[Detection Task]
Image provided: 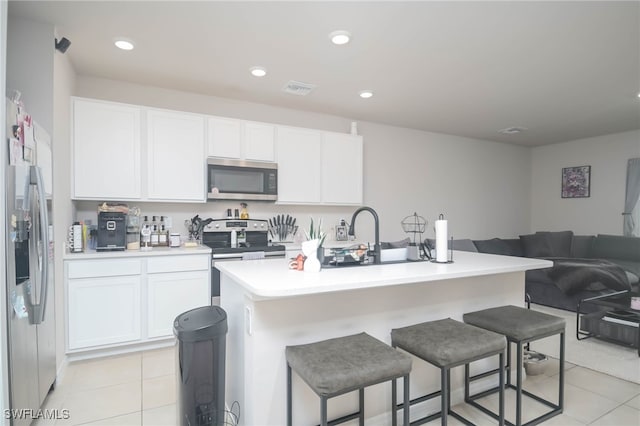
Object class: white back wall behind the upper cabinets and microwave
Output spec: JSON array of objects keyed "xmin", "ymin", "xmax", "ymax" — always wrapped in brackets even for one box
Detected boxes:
[{"xmin": 69, "ymin": 76, "xmax": 531, "ymax": 241}]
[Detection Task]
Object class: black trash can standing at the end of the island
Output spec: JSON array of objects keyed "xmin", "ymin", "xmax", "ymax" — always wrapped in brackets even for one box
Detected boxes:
[{"xmin": 173, "ymin": 306, "xmax": 227, "ymax": 426}]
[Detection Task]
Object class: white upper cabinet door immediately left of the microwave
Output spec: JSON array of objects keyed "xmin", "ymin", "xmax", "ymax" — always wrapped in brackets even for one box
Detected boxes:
[{"xmin": 147, "ymin": 110, "xmax": 206, "ymax": 202}]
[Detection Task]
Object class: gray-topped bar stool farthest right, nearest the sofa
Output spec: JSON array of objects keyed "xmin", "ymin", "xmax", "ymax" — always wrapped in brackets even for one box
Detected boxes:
[{"xmin": 463, "ymin": 305, "xmax": 565, "ymax": 426}]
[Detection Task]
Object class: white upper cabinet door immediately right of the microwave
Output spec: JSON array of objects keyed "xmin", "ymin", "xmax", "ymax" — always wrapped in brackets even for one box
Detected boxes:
[{"xmin": 276, "ymin": 127, "xmax": 322, "ymax": 204}]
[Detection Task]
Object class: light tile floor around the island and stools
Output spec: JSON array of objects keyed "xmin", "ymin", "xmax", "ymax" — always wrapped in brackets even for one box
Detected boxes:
[{"xmin": 36, "ymin": 347, "xmax": 640, "ymax": 426}]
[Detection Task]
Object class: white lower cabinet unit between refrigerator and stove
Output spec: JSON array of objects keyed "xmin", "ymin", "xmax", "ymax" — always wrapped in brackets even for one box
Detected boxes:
[{"xmin": 65, "ymin": 254, "xmax": 211, "ymax": 353}]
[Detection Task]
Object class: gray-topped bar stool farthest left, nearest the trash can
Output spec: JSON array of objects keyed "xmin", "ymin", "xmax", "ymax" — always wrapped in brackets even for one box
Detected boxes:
[{"xmin": 286, "ymin": 333, "xmax": 411, "ymax": 426}]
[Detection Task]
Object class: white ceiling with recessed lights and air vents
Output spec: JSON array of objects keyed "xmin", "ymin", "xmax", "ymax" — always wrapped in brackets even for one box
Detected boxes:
[{"xmin": 9, "ymin": 0, "xmax": 640, "ymax": 146}]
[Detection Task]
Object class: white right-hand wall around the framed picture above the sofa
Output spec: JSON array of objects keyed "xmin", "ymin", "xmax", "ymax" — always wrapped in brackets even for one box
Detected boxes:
[{"xmin": 531, "ymin": 131, "xmax": 640, "ymax": 235}]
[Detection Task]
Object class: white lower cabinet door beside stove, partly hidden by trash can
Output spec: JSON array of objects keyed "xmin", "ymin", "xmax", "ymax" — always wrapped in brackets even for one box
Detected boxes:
[{"xmin": 147, "ymin": 271, "xmax": 211, "ymax": 338}]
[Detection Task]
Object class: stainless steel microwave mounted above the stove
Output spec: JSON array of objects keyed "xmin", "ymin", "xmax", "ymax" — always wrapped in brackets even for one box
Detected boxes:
[{"xmin": 207, "ymin": 158, "xmax": 278, "ymax": 201}]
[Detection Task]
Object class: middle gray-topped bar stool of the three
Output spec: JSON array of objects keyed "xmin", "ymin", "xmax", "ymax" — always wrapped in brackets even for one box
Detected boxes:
[{"xmin": 391, "ymin": 318, "xmax": 507, "ymax": 426}]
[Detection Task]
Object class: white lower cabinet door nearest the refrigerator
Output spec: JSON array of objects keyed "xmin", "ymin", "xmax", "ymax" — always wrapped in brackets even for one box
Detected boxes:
[{"xmin": 67, "ymin": 275, "xmax": 141, "ymax": 350}]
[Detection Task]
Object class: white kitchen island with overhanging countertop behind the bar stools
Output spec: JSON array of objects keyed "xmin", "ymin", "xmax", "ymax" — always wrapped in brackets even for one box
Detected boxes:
[{"xmin": 216, "ymin": 252, "xmax": 552, "ymax": 426}]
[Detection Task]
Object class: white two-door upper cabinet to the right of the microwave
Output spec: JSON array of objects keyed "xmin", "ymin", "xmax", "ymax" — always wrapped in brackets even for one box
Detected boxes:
[{"xmin": 277, "ymin": 127, "xmax": 363, "ymax": 205}]
